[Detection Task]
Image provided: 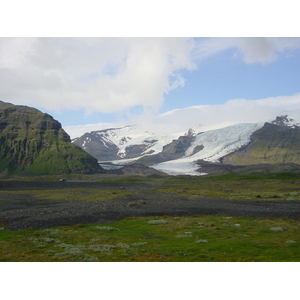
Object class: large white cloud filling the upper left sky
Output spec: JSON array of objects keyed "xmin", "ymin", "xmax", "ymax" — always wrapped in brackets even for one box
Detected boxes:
[{"xmin": 0, "ymin": 38, "xmax": 195, "ymax": 113}]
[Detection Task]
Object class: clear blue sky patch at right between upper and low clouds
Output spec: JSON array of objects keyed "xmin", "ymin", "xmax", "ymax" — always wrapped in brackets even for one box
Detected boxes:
[{"xmin": 162, "ymin": 50, "xmax": 300, "ymax": 110}]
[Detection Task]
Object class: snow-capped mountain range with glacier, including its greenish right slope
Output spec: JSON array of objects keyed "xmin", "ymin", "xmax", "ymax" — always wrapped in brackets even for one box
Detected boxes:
[{"xmin": 73, "ymin": 115, "xmax": 300, "ymax": 175}]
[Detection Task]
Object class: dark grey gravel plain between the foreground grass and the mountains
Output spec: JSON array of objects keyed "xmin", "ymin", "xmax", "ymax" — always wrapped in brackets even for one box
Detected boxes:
[{"xmin": 0, "ymin": 181, "xmax": 300, "ymax": 230}]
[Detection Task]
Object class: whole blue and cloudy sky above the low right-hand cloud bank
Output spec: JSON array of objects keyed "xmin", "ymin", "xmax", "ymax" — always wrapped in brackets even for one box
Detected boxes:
[{"xmin": 0, "ymin": 37, "xmax": 300, "ymax": 126}]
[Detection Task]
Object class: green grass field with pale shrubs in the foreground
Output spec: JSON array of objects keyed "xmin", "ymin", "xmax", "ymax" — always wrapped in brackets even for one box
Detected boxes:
[{"xmin": 0, "ymin": 216, "xmax": 300, "ymax": 262}]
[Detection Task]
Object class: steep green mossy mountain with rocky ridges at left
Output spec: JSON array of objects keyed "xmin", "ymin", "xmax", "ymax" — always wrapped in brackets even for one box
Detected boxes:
[{"xmin": 0, "ymin": 101, "xmax": 104, "ymax": 175}]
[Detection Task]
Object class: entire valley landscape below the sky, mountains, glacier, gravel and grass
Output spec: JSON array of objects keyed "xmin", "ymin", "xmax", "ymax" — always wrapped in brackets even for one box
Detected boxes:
[{"xmin": 0, "ymin": 102, "xmax": 300, "ymax": 261}]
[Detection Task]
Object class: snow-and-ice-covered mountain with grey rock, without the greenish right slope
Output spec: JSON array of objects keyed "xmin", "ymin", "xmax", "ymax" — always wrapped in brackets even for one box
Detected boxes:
[{"xmin": 73, "ymin": 116, "xmax": 300, "ymax": 175}]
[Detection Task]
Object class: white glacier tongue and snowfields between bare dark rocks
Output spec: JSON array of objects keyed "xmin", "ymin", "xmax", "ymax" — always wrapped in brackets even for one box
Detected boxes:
[{"xmin": 100, "ymin": 122, "xmax": 264, "ymax": 176}]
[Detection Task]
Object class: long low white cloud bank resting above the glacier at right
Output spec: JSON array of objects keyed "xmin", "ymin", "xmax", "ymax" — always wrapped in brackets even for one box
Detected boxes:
[{"xmin": 162, "ymin": 93, "xmax": 300, "ymax": 127}]
